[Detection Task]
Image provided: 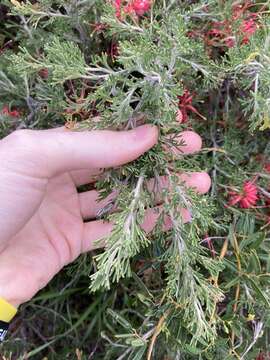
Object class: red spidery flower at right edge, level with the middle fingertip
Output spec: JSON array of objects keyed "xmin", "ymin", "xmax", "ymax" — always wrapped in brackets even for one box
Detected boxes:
[{"xmin": 228, "ymin": 181, "xmax": 259, "ymax": 209}]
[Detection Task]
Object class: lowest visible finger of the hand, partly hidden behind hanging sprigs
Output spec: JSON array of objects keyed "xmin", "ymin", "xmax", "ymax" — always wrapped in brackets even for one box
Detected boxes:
[{"xmin": 82, "ymin": 206, "xmax": 191, "ymax": 252}]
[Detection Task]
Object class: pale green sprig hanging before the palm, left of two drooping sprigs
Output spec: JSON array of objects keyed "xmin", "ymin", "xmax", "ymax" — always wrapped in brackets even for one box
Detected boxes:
[{"xmin": 91, "ymin": 175, "xmax": 150, "ymax": 291}]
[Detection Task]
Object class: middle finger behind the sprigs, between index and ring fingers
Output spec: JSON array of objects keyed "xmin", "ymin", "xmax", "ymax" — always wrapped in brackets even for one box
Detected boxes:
[{"xmin": 79, "ymin": 172, "xmax": 211, "ymax": 219}]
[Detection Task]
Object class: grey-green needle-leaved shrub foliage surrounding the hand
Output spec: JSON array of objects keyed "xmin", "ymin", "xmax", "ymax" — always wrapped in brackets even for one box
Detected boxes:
[{"xmin": 0, "ymin": 0, "xmax": 270, "ymax": 360}]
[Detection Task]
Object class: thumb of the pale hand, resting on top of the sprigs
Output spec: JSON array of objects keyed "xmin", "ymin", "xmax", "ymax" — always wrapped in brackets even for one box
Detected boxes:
[{"xmin": 45, "ymin": 125, "xmax": 158, "ymax": 173}]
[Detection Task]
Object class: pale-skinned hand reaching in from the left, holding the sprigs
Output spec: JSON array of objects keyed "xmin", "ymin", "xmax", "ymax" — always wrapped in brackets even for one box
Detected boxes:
[{"xmin": 0, "ymin": 125, "xmax": 211, "ymax": 307}]
